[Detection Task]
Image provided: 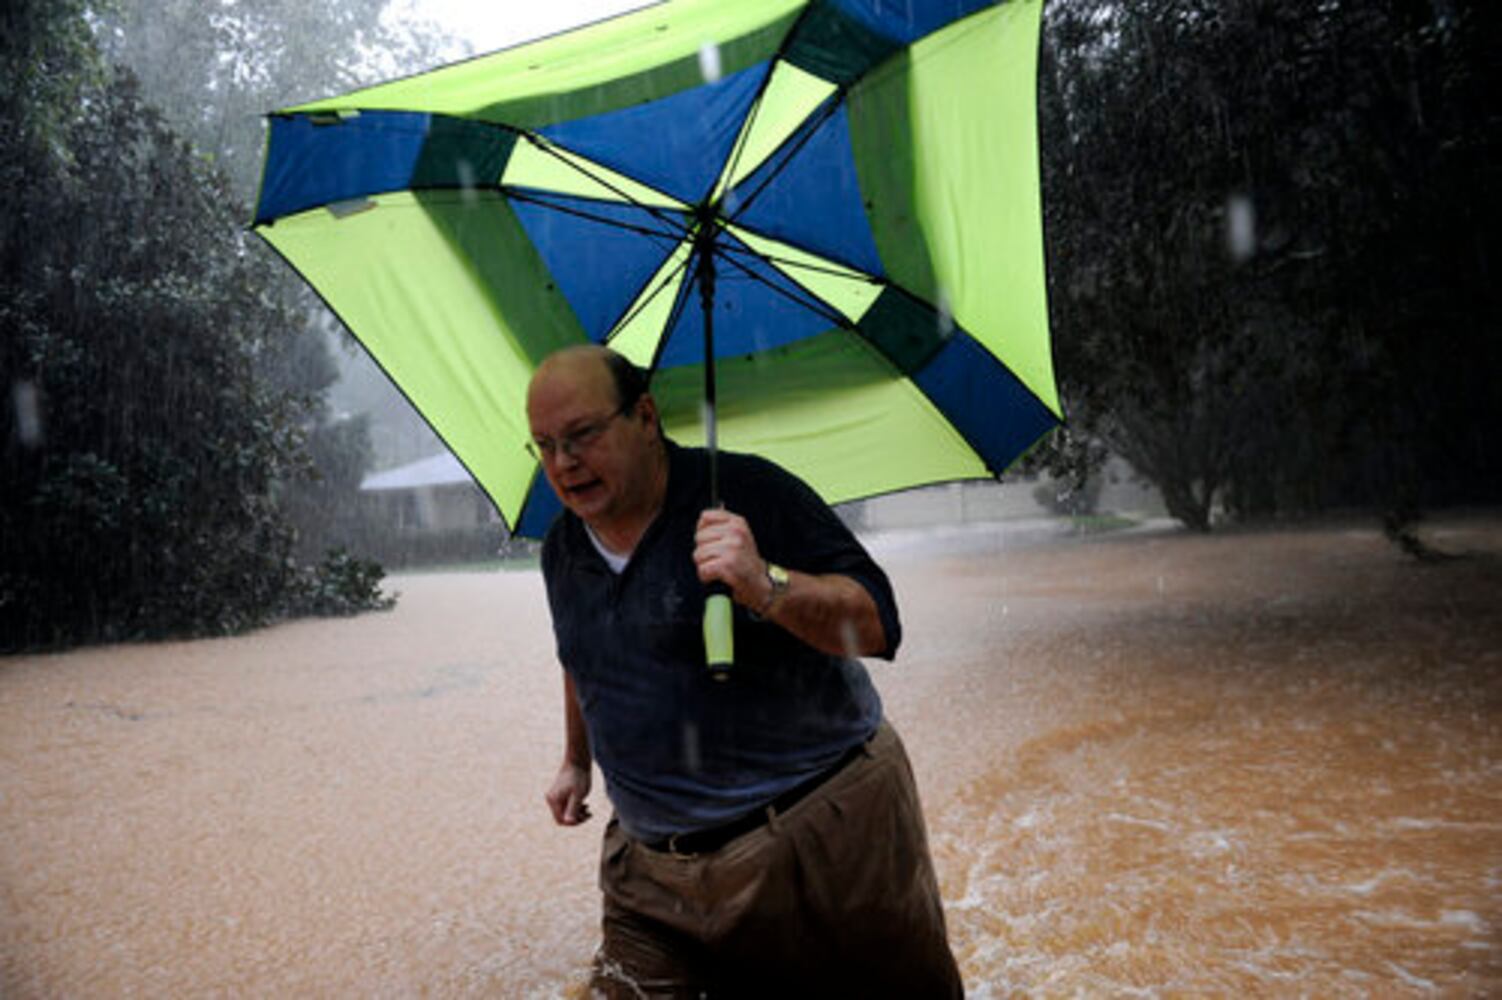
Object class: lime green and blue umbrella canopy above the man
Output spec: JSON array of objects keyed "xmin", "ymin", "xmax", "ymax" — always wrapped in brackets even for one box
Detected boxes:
[{"xmin": 254, "ymin": 0, "xmax": 1060, "ymax": 536}]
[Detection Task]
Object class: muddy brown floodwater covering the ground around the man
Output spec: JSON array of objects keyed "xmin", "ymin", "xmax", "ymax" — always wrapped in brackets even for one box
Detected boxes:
[{"xmin": 0, "ymin": 515, "xmax": 1502, "ymax": 997}]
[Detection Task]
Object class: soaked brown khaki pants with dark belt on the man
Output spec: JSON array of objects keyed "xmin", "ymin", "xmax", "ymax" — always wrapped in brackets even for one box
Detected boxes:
[{"xmin": 592, "ymin": 722, "xmax": 963, "ymax": 998}]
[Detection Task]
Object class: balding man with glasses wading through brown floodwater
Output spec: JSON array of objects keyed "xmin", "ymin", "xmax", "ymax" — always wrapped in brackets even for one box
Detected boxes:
[{"xmin": 527, "ymin": 347, "xmax": 961, "ymax": 997}]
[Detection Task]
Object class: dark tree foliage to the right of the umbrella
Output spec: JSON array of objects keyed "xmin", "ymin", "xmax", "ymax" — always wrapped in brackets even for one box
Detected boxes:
[{"xmin": 1039, "ymin": 0, "xmax": 1502, "ymax": 529}]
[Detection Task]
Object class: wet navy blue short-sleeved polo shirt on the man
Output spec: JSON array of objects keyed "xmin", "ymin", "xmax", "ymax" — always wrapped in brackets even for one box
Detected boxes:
[{"xmin": 542, "ymin": 441, "xmax": 901, "ymax": 841}]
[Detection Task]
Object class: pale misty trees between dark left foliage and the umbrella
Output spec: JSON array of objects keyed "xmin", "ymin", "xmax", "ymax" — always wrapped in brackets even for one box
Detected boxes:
[{"xmin": 98, "ymin": 0, "xmax": 456, "ymax": 559}]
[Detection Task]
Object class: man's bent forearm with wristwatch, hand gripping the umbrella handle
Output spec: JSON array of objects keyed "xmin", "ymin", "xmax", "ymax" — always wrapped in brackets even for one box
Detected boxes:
[{"xmin": 694, "ymin": 511, "xmax": 888, "ymax": 656}]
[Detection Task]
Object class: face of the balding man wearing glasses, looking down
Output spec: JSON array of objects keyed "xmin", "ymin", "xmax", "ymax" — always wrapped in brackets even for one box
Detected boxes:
[{"xmin": 527, "ymin": 354, "xmax": 656, "ymax": 530}]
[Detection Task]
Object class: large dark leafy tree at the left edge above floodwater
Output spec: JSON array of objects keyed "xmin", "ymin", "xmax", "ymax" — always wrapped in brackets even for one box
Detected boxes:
[{"xmin": 0, "ymin": 0, "xmax": 396, "ymax": 649}]
